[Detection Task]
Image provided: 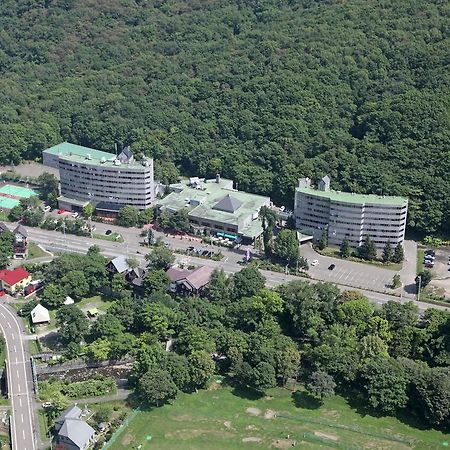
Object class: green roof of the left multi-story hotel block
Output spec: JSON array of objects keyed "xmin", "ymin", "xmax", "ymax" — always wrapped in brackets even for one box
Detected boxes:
[{"xmin": 44, "ymin": 142, "xmax": 149, "ymax": 171}]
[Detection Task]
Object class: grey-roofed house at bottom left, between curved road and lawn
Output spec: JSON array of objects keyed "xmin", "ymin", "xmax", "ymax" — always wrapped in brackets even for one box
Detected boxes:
[{"xmin": 54, "ymin": 405, "xmax": 95, "ymax": 450}]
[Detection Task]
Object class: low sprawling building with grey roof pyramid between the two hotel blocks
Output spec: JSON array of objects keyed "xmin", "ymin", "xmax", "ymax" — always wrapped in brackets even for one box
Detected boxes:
[{"xmin": 156, "ymin": 176, "xmax": 270, "ymax": 239}]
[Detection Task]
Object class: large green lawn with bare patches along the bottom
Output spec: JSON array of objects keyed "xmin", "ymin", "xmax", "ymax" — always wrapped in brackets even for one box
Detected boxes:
[{"xmin": 107, "ymin": 387, "xmax": 450, "ymax": 450}]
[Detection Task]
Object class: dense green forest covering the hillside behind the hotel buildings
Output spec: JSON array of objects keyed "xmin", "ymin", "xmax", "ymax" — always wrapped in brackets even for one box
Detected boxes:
[{"xmin": 0, "ymin": 0, "xmax": 450, "ymax": 233}]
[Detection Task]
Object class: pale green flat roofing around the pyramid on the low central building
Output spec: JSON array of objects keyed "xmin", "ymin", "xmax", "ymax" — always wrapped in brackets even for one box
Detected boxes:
[{"xmin": 157, "ymin": 179, "xmax": 270, "ymax": 237}]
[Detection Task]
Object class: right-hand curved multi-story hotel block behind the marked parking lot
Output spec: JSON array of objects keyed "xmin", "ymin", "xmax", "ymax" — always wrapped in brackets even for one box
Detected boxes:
[{"xmin": 294, "ymin": 176, "xmax": 408, "ymax": 248}]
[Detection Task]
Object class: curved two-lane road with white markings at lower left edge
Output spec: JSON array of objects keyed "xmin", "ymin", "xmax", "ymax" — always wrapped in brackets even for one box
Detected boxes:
[{"xmin": 0, "ymin": 303, "xmax": 36, "ymax": 450}]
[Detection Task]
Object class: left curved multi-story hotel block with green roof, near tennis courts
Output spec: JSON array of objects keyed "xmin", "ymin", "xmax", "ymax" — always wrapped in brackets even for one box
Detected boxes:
[{"xmin": 43, "ymin": 142, "xmax": 155, "ymax": 217}]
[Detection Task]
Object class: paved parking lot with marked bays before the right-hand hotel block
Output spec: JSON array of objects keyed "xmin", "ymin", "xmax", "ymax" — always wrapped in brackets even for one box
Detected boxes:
[{"xmin": 302, "ymin": 245, "xmax": 415, "ymax": 296}]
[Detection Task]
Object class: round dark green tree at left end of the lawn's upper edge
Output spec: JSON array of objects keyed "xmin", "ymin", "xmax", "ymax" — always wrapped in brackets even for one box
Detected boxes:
[{"xmin": 136, "ymin": 367, "xmax": 178, "ymax": 406}]
